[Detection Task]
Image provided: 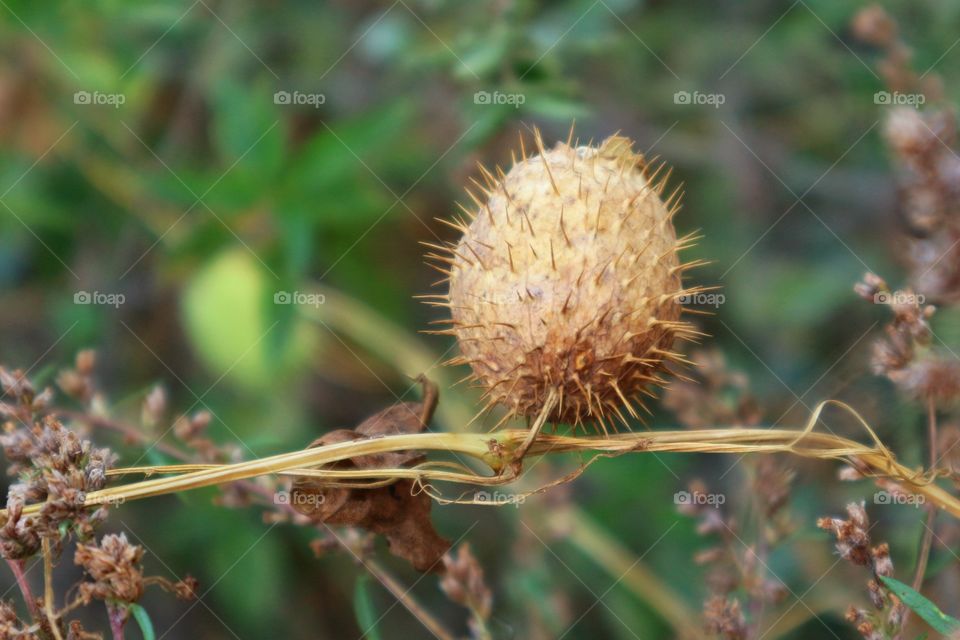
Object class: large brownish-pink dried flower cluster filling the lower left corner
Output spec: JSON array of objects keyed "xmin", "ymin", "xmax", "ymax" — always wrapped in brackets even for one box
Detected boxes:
[{"xmin": 0, "ymin": 360, "xmax": 196, "ymax": 640}]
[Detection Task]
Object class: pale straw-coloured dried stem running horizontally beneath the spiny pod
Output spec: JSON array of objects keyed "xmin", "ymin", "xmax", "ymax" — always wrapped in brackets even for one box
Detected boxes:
[{"xmin": 24, "ymin": 401, "xmax": 960, "ymax": 518}]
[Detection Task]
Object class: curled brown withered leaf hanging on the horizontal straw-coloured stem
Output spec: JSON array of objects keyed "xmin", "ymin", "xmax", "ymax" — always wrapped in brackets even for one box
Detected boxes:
[{"xmin": 290, "ymin": 376, "xmax": 450, "ymax": 571}]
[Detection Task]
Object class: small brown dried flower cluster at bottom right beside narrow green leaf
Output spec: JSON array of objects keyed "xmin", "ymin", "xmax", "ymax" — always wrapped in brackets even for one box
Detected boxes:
[{"xmin": 817, "ymin": 502, "xmax": 907, "ymax": 640}]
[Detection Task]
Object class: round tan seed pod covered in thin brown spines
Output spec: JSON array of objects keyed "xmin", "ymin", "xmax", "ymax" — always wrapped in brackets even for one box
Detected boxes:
[{"xmin": 426, "ymin": 131, "xmax": 702, "ymax": 429}]
